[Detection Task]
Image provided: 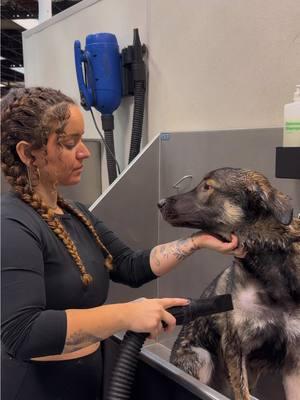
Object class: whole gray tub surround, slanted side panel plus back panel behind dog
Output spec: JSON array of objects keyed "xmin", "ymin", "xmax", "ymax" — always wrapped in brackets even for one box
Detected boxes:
[{"xmin": 90, "ymin": 128, "xmax": 300, "ymax": 400}]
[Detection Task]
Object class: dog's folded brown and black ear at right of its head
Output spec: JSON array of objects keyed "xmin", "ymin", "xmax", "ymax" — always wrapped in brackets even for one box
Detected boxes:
[{"xmin": 248, "ymin": 180, "xmax": 293, "ymax": 225}]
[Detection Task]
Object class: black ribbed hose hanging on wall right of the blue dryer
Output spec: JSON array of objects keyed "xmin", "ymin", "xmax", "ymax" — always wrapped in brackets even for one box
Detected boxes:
[{"xmin": 129, "ymin": 82, "xmax": 145, "ymax": 163}]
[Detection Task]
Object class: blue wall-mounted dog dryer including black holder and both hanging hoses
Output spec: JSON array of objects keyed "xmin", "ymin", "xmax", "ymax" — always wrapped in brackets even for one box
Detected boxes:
[{"xmin": 74, "ymin": 29, "xmax": 146, "ymax": 183}]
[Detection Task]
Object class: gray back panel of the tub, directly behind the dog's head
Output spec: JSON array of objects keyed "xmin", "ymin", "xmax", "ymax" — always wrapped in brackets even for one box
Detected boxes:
[{"xmin": 159, "ymin": 128, "xmax": 300, "ymax": 297}]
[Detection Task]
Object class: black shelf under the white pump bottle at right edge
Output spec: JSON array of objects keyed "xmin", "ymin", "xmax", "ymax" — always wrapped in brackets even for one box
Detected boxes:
[{"xmin": 275, "ymin": 147, "xmax": 300, "ymax": 179}]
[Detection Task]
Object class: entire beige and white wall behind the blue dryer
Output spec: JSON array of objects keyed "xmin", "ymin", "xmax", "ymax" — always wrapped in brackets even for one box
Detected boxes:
[{"xmin": 24, "ymin": 0, "xmax": 300, "ymax": 187}]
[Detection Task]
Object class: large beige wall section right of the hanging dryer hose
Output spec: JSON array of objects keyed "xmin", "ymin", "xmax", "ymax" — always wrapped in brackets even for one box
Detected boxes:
[{"xmin": 148, "ymin": 0, "xmax": 300, "ymax": 136}]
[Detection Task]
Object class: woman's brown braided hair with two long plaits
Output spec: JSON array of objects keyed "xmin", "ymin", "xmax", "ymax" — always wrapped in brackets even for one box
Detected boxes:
[{"xmin": 1, "ymin": 87, "xmax": 113, "ymax": 286}]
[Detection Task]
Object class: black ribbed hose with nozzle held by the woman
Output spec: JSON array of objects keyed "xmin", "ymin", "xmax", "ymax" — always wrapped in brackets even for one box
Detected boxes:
[{"xmin": 107, "ymin": 294, "xmax": 233, "ymax": 400}]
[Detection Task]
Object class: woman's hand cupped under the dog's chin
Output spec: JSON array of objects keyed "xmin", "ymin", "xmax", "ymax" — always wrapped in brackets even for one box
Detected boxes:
[{"xmin": 192, "ymin": 232, "xmax": 247, "ymax": 258}]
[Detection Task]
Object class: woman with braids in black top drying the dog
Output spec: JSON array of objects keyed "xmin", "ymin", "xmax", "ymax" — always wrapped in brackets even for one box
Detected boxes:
[{"xmin": 1, "ymin": 88, "xmax": 244, "ymax": 400}]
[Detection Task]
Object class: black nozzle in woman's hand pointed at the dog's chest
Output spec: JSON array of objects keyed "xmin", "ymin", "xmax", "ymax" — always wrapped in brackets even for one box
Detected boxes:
[{"xmin": 167, "ymin": 294, "xmax": 233, "ymax": 325}]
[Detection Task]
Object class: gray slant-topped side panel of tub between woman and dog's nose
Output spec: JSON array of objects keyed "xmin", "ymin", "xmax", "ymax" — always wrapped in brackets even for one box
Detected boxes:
[{"xmin": 93, "ymin": 141, "xmax": 159, "ymax": 302}]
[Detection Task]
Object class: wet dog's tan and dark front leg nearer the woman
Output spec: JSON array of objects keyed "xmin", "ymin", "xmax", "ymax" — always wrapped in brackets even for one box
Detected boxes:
[{"xmin": 222, "ymin": 332, "xmax": 250, "ymax": 400}]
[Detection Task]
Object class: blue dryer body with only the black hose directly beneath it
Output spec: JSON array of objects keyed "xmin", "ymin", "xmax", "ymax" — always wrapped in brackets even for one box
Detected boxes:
[{"xmin": 74, "ymin": 33, "xmax": 122, "ymax": 183}]
